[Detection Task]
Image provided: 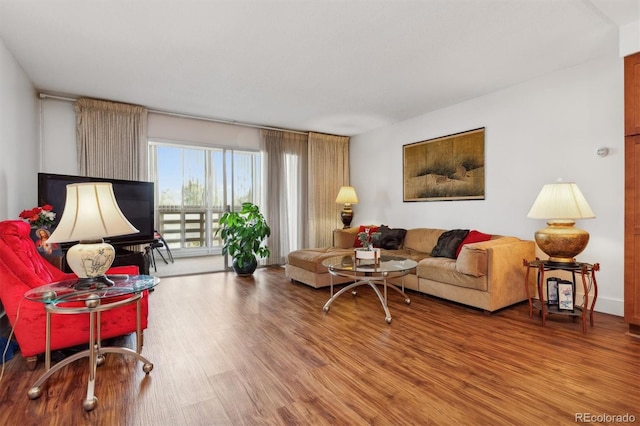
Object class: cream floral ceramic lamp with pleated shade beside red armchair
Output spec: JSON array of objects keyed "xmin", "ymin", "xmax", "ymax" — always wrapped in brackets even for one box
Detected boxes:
[{"xmin": 48, "ymin": 182, "xmax": 140, "ymax": 289}]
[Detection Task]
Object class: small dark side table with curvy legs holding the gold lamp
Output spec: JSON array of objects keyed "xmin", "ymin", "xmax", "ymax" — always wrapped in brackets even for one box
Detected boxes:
[{"xmin": 523, "ymin": 259, "xmax": 600, "ymax": 333}]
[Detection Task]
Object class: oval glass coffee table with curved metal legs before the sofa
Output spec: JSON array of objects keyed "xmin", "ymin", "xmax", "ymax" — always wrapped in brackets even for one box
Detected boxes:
[{"xmin": 322, "ymin": 255, "xmax": 418, "ymax": 324}]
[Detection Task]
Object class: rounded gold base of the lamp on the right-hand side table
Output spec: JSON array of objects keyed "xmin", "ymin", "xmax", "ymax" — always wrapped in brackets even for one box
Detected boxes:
[{"xmin": 535, "ymin": 220, "xmax": 589, "ymax": 265}]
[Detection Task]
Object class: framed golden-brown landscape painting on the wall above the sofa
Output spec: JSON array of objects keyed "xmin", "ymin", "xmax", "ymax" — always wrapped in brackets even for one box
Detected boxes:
[{"xmin": 403, "ymin": 128, "xmax": 484, "ymax": 201}]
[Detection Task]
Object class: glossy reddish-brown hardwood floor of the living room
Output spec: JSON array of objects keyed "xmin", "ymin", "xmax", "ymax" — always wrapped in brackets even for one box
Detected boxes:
[{"xmin": 0, "ymin": 267, "xmax": 640, "ymax": 425}]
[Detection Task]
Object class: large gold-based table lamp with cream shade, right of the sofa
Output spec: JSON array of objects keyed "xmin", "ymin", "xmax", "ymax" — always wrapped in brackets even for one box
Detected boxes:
[{"xmin": 527, "ymin": 179, "xmax": 596, "ymax": 264}]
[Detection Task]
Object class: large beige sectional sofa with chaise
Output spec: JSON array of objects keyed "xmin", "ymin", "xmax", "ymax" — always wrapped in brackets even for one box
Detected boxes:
[{"xmin": 285, "ymin": 227, "xmax": 535, "ymax": 312}]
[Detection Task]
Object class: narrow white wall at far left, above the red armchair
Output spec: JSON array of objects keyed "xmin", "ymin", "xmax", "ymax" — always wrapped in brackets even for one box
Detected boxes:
[{"xmin": 0, "ymin": 39, "xmax": 40, "ymax": 220}]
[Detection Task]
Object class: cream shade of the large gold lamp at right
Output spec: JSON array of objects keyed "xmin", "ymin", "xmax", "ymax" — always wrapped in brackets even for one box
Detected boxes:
[{"xmin": 527, "ymin": 182, "xmax": 596, "ymax": 220}]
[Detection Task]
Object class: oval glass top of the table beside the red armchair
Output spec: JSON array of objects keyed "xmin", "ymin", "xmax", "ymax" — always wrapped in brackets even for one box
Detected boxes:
[{"xmin": 24, "ymin": 275, "xmax": 160, "ymax": 303}]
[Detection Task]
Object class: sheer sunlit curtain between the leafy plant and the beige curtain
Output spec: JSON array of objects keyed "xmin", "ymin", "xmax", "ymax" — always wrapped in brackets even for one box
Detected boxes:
[{"xmin": 260, "ymin": 130, "xmax": 309, "ymax": 264}]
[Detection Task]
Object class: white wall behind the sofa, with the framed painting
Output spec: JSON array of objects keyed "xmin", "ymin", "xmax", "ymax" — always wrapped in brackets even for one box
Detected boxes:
[{"xmin": 350, "ymin": 50, "xmax": 624, "ymax": 316}]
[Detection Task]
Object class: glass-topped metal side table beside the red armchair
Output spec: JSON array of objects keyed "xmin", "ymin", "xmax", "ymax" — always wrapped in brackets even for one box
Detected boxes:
[{"xmin": 24, "ymin": 275, "xmax": 160, "ymax": 411}]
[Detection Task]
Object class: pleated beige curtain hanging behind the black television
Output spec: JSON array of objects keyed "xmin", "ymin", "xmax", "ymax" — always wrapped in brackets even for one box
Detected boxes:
[{"xmin": 75, "ymin": 98, "xmax": 148, "ymax": 180}]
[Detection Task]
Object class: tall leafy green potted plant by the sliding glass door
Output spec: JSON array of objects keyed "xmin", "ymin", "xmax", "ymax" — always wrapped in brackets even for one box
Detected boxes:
[{"xmin": 215, "ymin": 203, "xmax": 271, "ymax": 276}]
